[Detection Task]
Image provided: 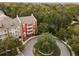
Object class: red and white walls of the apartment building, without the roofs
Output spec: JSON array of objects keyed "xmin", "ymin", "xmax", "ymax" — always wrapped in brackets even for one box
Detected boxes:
[{"xmin": 0, "ymin": 21, "xmax": 37, "ymax": 39}]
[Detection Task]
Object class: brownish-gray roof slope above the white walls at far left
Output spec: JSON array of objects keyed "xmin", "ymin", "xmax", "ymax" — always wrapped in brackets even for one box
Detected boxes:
[{"xmin": 0, "ymin": 16, "xmax": 19, "ymax": 31}]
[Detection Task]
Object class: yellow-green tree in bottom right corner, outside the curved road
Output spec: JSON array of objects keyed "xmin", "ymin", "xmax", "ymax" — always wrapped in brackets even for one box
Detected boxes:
[{"xmin": 68, "ymin": 35, "xmax": 79, "ymax": 56}]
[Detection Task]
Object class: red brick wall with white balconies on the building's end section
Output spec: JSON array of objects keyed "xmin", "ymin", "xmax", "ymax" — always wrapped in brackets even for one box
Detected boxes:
[{"xmin": 21, "ymin": 21, "xmax": 36, "ymax": 37}]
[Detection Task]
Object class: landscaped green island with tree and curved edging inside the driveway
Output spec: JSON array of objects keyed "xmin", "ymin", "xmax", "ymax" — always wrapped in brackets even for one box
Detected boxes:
[{"xmin": 33, "ymin": 33, "xmax": 60, "ymax": 56}]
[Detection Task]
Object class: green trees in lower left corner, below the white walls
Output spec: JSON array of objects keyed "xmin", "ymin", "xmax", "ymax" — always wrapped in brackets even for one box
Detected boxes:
[{"xmin": 0, "ymin": 36, "xmax": 23, "ymax": 56}]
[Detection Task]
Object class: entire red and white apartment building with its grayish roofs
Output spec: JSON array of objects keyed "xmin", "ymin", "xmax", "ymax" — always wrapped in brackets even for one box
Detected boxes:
[{"xmin": 0, "ymin": 12, "xmax": 37, "ymax": 39}]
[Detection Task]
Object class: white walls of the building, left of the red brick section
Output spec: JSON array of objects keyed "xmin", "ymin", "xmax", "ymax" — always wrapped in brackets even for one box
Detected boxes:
[{"xmin": 0, "ymin": 27, "xmax": 21, "ymax": 39}]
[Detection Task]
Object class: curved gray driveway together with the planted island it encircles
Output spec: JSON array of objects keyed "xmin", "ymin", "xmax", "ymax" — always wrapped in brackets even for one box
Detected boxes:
[{"xmin": 22, "ymin": 33, "xmax": 73, "ymax": 56}]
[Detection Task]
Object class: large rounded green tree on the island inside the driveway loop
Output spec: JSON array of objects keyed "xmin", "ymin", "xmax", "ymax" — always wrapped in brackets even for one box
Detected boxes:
[{"xmin": 37, "ymin": 33, "xmax": 56, "ymax": 53}]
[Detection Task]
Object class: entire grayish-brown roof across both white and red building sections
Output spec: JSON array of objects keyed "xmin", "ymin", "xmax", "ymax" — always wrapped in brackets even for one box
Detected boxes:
[{"xmin": 0, "ymin": 14, "xmax": 36, "ymax": 32}]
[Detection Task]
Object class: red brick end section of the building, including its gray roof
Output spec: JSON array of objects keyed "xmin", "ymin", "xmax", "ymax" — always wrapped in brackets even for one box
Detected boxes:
[{"xmin": 16, "ymin": 14, "xmax": 37, "ymax": 38}]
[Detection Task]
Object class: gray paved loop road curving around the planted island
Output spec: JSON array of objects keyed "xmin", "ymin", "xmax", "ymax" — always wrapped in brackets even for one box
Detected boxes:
[{"xmin": 20, "ymin": 39, "xmax": 70, "ymax": 56}]
